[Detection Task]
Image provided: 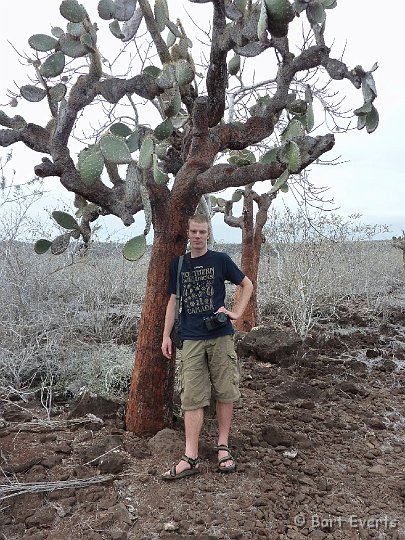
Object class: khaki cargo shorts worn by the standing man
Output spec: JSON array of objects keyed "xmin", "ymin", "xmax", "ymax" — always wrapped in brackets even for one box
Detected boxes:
[{"xmin": 180, "ymin": 335, "xmax": 240, "ymax": 411}]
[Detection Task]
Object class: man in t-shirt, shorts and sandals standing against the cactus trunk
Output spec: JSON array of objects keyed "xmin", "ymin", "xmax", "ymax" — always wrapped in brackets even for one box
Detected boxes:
[{"xmin": 162, "ymin": 215, "xmax": 253, "ymax": 480}]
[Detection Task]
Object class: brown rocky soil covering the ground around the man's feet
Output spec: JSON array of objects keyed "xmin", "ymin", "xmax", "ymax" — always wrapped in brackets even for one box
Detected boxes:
[{"xmin": 0, "ymin": 307, "xmax": 405, "ymax": 540}]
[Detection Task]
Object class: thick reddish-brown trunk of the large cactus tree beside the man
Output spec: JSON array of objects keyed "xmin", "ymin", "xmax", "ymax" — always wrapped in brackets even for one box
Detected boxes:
[{"xmin": 126, "ymin": 175, "xmax": 204, "ymax": 436}]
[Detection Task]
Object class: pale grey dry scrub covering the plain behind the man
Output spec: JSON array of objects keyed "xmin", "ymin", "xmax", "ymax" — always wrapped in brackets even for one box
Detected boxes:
[{"xmin": 0, "ymin": 226, "xmax": 404, "ymax": 413}]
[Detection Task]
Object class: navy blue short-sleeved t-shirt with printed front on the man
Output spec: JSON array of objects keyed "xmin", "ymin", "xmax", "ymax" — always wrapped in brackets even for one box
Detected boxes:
[{"xmin": 169, "ymin": 250, "xmax": 245, "ymax": 340}]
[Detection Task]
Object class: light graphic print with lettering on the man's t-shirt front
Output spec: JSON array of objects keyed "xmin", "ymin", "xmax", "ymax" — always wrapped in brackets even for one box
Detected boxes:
[{"xmin": 181, "ymin": 266, "xmax": 215, "ymax": 315}]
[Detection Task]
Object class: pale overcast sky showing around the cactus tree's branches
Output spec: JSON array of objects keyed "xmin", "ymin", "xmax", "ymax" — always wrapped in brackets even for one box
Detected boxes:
[{"xmin": 0, "ymin": 0, "xmax": 405, "ymax": 242}]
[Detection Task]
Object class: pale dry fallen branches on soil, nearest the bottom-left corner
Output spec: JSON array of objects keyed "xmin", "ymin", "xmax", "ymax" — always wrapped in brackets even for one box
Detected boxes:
[{"xmin": 0, "ymin": 474, "xmax": 115, "ymax": 501}]
